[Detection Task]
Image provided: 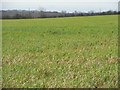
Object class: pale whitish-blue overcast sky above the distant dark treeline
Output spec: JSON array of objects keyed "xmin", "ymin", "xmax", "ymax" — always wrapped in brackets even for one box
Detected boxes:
[{"xmin": 0, "ymin": 0, "xmax": 119, "ymax": 12}]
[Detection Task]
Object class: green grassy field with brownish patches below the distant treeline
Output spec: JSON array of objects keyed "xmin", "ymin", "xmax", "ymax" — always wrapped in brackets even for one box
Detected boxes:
[{"xmin": 2, "ymin": 15, "xmax": 118, "ymax": 88}]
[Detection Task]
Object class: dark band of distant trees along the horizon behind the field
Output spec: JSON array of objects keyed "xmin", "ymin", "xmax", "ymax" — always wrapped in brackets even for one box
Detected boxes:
[{"xmin": 0, "ymin": 10, "xmax": 120, "ymax": 19}]
